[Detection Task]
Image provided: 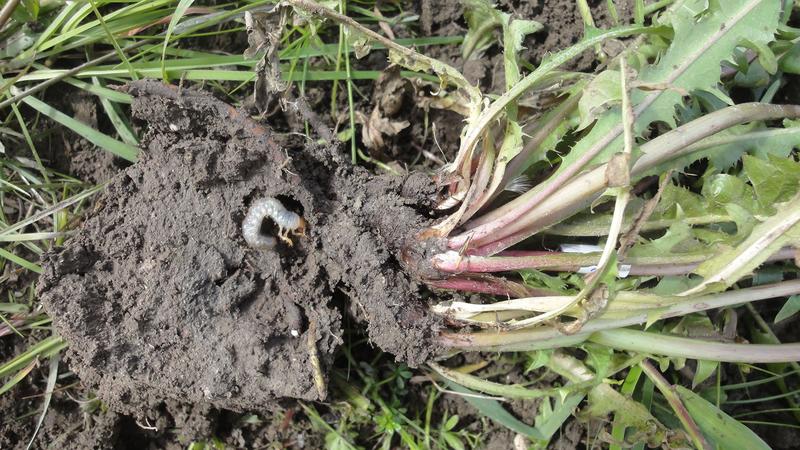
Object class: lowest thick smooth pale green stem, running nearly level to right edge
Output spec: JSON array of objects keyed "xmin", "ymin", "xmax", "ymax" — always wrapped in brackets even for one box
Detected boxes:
[{"xmin": 589, "ymin": 329, "xmax": 800, "ymax": 364}]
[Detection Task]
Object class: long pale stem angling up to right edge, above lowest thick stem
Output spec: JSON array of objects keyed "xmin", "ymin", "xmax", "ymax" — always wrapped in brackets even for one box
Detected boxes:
[{"xmin": 439, "ymin": 280, "xmax": 800, "ymax": 351}]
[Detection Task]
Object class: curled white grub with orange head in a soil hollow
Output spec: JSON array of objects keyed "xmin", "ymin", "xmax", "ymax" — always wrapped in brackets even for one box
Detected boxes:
[{"xmin": 242, "ymin": 197, "xmax": 306, "ymax": 250}]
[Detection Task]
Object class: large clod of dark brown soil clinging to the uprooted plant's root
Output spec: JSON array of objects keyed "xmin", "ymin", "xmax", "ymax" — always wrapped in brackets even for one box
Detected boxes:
[{"xmin": 39, "ymin": 81, "xmax": 439, "ymax": 412}]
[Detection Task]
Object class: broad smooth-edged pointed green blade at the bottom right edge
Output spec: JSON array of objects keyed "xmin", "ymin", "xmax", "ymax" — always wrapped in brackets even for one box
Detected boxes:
[{"xmin": 675, "ymin": 385, "xmax": 770, "ymax": 450}]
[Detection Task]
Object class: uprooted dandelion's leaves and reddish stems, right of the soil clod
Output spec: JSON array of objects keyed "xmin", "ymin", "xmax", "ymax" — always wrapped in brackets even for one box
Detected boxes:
[{"xmin": 286, "ymin": 0, "xmax": 800, "ymax": 448}]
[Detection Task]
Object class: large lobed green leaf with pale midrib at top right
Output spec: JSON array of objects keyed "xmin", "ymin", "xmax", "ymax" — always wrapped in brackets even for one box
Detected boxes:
[{"xmin": 559, "ymin": 0, "xmax": 780, "ymax": 179}]
